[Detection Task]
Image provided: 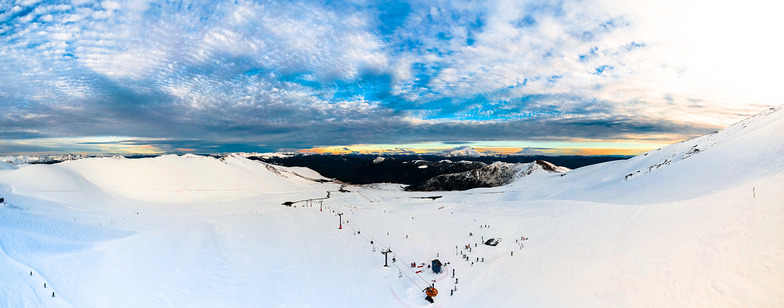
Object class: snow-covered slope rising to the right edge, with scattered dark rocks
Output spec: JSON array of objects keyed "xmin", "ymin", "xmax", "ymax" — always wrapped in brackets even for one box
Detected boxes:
[{"xmin": 513, "ymin": 108, "xmax": 784, "ymax": 204}]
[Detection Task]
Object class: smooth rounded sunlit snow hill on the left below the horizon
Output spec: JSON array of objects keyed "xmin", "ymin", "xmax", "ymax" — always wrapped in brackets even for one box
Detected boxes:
[{"xmin": 3, "ymin": 154, "xmax": 324, "ymax": 202}]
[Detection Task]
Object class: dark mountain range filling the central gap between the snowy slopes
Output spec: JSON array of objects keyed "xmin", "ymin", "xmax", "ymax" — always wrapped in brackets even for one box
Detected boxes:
[{"xmin": 254, "ymin": 153, "xmax": 628, "ymax": 190}]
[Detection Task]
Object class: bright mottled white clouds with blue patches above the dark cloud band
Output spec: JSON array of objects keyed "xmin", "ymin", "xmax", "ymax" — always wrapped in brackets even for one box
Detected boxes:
[{"xmin": 0, "ymin": 0, "xmax": 784, "ymax": 150}]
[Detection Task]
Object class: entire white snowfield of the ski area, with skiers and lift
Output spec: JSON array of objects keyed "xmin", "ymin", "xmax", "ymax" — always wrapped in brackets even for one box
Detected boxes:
[{"xmin": 0, "ymin": 108, "xmax": 784, "ymax": 307}]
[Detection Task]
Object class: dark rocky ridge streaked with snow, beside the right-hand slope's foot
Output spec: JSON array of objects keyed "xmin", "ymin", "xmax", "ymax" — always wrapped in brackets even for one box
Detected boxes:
[{"xmin": 407, "ymin": 160, "xmax": 569, "ymax": 191}]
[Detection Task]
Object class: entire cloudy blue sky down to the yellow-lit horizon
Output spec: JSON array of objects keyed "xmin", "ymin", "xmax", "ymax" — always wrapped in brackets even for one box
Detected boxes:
[{"xmin": 0, "ymin": 0, "xmax": 784, "ymax": 155}]
